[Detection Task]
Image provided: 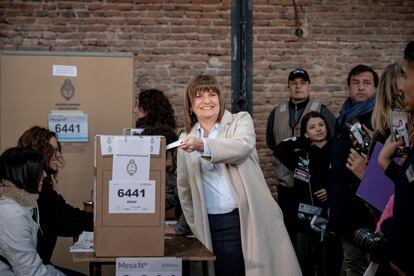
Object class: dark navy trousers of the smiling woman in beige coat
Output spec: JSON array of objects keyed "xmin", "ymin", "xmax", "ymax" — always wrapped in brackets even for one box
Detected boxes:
[{"xmin": 208, "ymin": 209, "xmax": 245, "ymax": 276}]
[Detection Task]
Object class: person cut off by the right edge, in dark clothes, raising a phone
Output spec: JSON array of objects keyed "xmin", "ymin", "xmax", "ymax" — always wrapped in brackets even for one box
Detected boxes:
[{"xmin": 378, "ymin": 41, "xmax": 414, "ymax": 275}]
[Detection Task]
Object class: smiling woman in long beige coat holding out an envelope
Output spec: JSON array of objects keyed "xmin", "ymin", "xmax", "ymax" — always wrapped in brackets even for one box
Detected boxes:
[{"xmin": 177, "ymin": 75, "xmax": 302, "ymax": 276}]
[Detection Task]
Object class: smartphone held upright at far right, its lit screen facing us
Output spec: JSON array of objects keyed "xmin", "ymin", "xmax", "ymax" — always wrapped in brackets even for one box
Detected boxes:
[{"xmin": 389, "ymin": 109, "xmax": 410, "ymax": 155}]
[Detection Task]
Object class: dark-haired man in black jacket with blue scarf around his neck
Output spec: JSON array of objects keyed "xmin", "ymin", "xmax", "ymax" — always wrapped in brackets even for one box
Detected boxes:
[{"xmin": 328, "ymin": 65, "xmax": 378, "ymax": 276}]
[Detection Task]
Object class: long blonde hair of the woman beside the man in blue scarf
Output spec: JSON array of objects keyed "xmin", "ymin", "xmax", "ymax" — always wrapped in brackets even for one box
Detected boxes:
[{"xmin": 371, "ymin": 62, "xmax": 405, "ymax": 135}]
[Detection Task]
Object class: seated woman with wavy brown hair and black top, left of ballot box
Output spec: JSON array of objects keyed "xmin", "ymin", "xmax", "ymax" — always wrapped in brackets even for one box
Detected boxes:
[{"xmin": 18, "ymin": 126, "xmax": 93, "ymax": 275}]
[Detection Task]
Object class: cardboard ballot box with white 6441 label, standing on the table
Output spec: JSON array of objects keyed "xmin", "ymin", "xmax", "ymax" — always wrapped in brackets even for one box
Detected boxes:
[{"xmin": 94, "ymin": 136, "xmax": 166, "ymax": 257}]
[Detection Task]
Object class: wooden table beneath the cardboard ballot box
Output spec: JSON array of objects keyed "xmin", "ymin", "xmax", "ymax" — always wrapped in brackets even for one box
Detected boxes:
[{"xmin": 71, "ymin": 235, "xmax": 216, "ymax": 276}]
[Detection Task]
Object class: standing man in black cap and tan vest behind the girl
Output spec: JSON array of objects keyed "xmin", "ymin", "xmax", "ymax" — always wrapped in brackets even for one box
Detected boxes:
[{"xmin": 266, "ymin": 68, "xmax": 335, "ymax": 239}]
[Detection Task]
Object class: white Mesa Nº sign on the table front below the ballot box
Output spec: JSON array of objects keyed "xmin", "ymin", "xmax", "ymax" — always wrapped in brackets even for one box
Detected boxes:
[{"xmin": 115, "ymin": 257, "xmax": 182, "ymax": 276}]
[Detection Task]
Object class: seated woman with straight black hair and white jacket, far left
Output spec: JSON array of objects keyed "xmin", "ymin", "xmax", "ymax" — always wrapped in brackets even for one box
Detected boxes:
[{"xmin": 0, "ymin": 148, "xmax": 65, "ymax": 276}]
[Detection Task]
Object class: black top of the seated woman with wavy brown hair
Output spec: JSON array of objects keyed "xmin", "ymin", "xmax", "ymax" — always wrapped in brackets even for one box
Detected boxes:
[{"xmin": 37, "ymin": 188, "xmax": 93, "ymax": 264}]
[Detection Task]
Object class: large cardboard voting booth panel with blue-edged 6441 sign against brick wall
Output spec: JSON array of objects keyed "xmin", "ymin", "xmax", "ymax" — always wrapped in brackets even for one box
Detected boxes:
[{"xmin": 0, "ymin": 51, "xmax": 133, "ymax": 274}]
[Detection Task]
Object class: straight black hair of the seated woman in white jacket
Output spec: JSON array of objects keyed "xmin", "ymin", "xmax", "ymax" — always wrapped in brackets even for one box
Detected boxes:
[{"xmin": 0, "ymin": 147, "xmax": 43, "ymax": 194}]
